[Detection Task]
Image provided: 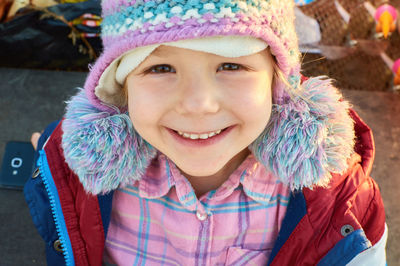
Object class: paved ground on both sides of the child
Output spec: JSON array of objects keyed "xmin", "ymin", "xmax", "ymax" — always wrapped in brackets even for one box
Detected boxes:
[{"xmin": 0, "ymin": 68, "xmax": 400, "ymax": 266}]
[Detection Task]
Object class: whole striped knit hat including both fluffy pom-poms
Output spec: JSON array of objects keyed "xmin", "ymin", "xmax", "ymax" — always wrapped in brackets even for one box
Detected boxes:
[{"xmin": 62, "ymin": 0, "xmax": 354, "ymax": 194}]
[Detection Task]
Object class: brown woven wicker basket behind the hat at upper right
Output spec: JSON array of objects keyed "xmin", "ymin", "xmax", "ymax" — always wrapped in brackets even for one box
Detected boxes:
[{"xmin": 300, "ymin": 0, "xmax": 400, "ymax": 91}]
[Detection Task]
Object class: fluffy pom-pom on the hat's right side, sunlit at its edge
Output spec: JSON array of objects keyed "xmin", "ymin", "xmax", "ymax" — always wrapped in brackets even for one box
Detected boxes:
[{"xmin": 249, "ymin": 76, "xmax": 355, "ymax": 190}]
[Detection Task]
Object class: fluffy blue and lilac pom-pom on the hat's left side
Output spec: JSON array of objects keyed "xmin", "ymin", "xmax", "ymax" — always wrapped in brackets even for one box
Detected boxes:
[{"xmin": 62, "ymin": 90, "xmax": 156, "ymax": 194}]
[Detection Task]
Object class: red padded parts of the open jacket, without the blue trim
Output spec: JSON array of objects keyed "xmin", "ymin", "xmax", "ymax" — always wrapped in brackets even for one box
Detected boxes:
[{"xmin": 39, "ymin": 110, "xmax": 385, "ymax": 266}]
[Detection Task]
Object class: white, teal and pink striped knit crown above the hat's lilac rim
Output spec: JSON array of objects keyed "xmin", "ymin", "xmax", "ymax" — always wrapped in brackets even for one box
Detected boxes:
[{"xmin": 102, "ymin": 0, "xmax": 298, "ymax": 60}]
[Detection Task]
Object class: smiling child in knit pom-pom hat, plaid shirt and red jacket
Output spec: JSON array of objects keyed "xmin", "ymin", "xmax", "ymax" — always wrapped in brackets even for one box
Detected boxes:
[{"xmin": 25, "ymin": 0, "xmax": 387, "ymax": 265}]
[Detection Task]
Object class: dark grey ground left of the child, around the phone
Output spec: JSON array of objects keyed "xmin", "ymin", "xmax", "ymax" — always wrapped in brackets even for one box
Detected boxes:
[{"xmin": 0, "ymin": 68, "xmax": 85, "ymax": 266}]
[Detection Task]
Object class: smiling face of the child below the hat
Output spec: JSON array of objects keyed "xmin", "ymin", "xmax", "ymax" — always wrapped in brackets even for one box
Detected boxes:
[{"xmin": 126, "ymin": 46, "xmax": 273, "ymax": 177}]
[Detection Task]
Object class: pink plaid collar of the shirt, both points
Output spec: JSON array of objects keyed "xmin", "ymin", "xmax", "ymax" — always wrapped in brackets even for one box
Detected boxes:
[{"xmin": 138, "ymin": 153, "xmax": 288, "ymax": 210}]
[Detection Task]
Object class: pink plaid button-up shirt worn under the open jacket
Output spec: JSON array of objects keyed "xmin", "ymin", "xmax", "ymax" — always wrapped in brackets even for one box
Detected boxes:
[{"xmin": 104, "ymin": 155, "xmax": 289, "ymax": 265}]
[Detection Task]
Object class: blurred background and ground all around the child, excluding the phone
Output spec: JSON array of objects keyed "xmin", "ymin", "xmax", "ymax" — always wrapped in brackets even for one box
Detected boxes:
[{"xmin": 0, "ymin": 0, "xmax": 400, "ymax": 265}]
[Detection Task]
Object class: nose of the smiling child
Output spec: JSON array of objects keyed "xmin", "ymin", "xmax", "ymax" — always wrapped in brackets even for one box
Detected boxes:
[{"xmin": 177, "ymin": 72, "xmax": 221, "ymax": 115}]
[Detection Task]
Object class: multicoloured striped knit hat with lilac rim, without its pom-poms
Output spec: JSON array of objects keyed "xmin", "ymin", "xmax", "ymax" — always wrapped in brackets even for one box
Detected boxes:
[{"xmin": 85, "ymin": 0, "xmax": 300, "ymax": 111}]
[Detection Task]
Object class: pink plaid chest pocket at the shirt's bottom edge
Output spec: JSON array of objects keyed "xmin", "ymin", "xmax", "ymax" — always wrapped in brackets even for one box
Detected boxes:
[{"xmin": 225, "ymin": 247, "xmax": 272, "ymax": 266}]
